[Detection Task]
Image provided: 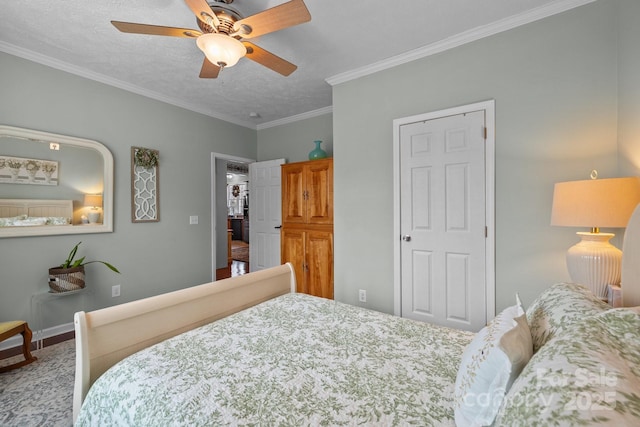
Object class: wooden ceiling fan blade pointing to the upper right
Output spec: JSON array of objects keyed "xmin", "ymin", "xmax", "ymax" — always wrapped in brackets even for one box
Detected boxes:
[{"xmin": 233, "ymin": 0, "xmax": 311, "ymax": 39}]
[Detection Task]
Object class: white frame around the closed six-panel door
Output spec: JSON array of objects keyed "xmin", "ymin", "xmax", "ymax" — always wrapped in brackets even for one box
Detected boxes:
[{"xmin": 393, "ymin": 99, "xmax": 496, "ymax": 322}]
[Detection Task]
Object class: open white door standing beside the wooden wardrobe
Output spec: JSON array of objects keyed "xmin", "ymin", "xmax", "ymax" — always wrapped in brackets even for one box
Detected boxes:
[{"xmin": 249, "ymin": 159, "xmax": 284, "ymax": 271}]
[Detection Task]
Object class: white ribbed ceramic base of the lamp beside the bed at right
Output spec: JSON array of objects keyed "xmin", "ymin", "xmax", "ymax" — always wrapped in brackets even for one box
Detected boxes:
[{"xmin": 567, "ymin": 232, "xmax": 622, "ymax": 299}]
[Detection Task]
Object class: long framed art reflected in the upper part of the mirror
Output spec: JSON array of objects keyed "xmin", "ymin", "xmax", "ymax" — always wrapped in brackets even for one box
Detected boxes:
[{"xmin": 0, "ymin": 156, "xmax": 58, "ymax": 185}]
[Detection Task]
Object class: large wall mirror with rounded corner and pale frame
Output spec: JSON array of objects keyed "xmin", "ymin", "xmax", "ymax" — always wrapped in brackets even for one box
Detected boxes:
[{"xmin": 0, "ymin": 125, "xmax": 113, "ymax": 237}]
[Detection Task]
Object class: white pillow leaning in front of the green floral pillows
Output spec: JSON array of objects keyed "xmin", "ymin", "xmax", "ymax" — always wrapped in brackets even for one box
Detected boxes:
[{"xmin": 454, "ymin": 295, "xmax": 533, "ymax": 427}]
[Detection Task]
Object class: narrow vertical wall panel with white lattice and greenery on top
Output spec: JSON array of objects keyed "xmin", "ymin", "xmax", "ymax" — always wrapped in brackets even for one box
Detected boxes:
[{"xmin": 131, "ymin": 147, "xmax": 160, "ymax": 222}]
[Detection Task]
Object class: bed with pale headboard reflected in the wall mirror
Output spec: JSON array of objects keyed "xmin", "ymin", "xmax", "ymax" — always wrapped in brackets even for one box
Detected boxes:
[{"xmin": 0, "ymin": 199, "xmax": 73, "ymax": 228}]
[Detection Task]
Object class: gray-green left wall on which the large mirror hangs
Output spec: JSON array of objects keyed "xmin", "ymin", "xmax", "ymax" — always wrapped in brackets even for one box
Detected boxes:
[{"xmin": 0, "ymin": 53, "xmax": 257, "ymax": 327}]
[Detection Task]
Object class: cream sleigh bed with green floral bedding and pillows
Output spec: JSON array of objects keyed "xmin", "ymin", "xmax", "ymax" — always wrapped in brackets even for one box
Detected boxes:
[{"xmin": 74, "ymin": 213, "xmax": 640, "ymax": 426}]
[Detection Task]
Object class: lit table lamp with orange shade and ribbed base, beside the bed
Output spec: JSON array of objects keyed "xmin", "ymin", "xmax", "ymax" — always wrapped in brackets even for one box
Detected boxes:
[{"xmin": 551, "ymin": 176, "xmax": 640, "ymax": 299}]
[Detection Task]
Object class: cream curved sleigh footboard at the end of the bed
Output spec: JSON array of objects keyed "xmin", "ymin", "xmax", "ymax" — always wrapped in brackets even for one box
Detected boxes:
[{"xmin": 73, "ymin": 263, "xmax": 296, "ymax": 421}]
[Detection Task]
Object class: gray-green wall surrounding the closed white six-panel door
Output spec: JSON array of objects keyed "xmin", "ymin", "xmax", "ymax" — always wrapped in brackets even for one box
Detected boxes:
[{"xmin": 333, "ymin": 0, "xmax": 639, "ymax": 312}]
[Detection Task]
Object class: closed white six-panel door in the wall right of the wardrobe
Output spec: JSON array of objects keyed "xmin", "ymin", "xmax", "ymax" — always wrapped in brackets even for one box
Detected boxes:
[{"xmin": 399, "ymin": 111, "xmax": 487, "ymax": 331}]
